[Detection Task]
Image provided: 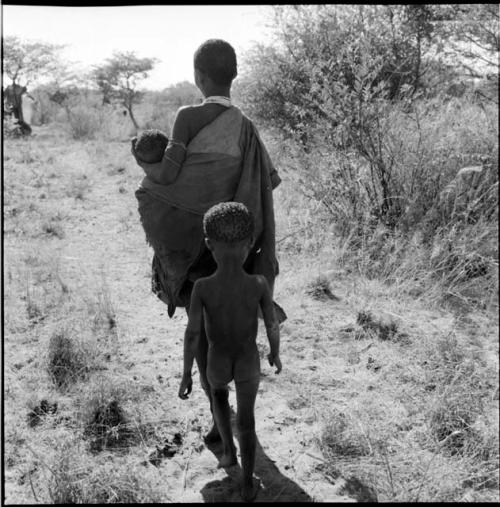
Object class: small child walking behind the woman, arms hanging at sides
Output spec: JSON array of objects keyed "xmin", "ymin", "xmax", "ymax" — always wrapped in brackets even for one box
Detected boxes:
[{"xmin": 179, "ymin": 202, "xmax": 281, "ymax": 502}]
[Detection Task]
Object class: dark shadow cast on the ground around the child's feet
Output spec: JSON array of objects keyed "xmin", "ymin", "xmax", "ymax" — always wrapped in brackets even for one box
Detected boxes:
[{"xmin": 200, "ymin": 411, "xmax": 313, "ymax": 503}]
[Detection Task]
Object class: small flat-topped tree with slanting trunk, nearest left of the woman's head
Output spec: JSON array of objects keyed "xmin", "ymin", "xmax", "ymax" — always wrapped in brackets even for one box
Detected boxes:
[{"xmin": 93, "ymin": 52, "xmax": 158, "ymax": 129}]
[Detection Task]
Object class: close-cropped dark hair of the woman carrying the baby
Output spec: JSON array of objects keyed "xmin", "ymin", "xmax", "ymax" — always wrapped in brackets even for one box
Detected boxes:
[{"xmin": 194, "ymin": 39, "xmax": 238, "ymax": 86}]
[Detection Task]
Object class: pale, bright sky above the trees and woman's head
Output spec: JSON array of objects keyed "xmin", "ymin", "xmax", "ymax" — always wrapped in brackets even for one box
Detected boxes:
[{"xmin": 2, "ymin": 5, "xmax": 276, "ymax": 90}]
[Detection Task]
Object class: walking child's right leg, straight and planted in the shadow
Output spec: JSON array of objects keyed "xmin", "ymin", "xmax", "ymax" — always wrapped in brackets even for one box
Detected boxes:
[{"xmin": 236, "ymin": 378, "xmax": 259, "ymax": 501}]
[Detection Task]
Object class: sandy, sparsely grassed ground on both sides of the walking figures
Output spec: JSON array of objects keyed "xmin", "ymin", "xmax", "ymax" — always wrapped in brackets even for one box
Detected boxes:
[{"xmin": 4, "ymin": 127, "xmax": 499, "ymax": 504}]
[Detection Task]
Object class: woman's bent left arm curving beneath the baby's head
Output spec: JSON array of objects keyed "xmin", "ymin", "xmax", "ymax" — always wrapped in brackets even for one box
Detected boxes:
[{"xmin": 132, "ymin": 108, "xmax": 190, "ymax": 185}]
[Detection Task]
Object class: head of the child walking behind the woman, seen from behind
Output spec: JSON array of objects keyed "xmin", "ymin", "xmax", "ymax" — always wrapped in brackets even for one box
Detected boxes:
[{"xmin": 203, "ymin": 202, "xmax": 255, "ymax": 261}]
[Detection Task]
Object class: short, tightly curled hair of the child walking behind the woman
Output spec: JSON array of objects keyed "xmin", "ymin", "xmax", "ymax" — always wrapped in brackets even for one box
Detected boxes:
[{"xmin": 203, "ymin": 202, "xmax": 254, "ymax": 243}]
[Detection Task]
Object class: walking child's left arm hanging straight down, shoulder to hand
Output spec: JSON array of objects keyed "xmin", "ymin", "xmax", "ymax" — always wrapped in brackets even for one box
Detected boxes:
[{"xmin": 179, "ymin": 282, "xmax": 203, "ymax": 400}]
